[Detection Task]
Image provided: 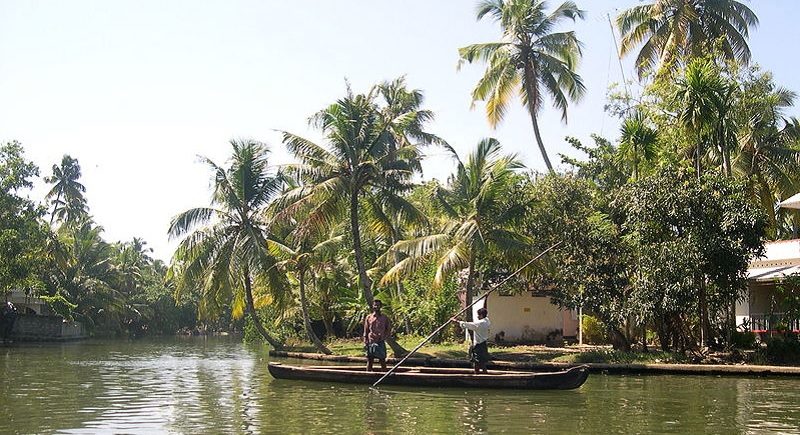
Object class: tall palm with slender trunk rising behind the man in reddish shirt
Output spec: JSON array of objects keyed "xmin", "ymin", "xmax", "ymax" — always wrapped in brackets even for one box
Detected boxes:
[{"xmin": 276, "ymin": 81, "xmax": 444, "ymax": 303}]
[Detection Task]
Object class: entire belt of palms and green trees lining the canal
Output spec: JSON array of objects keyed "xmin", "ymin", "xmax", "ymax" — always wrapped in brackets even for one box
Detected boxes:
[{"xmin": 0, "ymin": 0, "xmax": 800, "ymax": 353}]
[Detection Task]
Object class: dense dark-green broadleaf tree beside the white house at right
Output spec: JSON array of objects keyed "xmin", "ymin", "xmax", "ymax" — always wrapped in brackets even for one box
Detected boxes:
[{"xmin": 612, "ymin": 167, "xmax": 766, "ymax": 349}]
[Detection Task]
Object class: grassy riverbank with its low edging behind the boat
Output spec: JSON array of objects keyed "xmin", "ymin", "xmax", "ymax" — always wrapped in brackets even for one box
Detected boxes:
[{"xmin": 270, "ymin": 340, "xmax": 800, "ymax": 377}]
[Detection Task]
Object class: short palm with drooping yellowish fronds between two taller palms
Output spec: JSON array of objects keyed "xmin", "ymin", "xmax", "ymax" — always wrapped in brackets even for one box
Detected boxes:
[{"xmin": 267, "ymin": 230, "xmax": 344, "ymax": 355}]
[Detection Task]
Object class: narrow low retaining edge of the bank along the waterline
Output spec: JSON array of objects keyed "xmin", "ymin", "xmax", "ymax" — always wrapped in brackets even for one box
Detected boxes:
[{"xmin": 269, "ymin": 350, "xmax": 800, "ymax": 377}]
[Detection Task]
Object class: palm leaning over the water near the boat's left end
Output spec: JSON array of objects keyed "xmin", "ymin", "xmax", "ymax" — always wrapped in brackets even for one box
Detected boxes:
[{"xmin": 169, "ymin": 140, "xmax": 288, "ymax": 348}]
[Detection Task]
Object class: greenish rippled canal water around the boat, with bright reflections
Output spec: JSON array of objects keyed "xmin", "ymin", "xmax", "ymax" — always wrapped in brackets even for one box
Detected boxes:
[{"xmin": 0, "ymin": 337, "xmax": 800, "ymax": 434}]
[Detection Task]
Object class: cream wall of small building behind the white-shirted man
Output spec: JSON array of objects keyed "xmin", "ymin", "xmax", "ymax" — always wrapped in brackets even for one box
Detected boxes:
[{"xmin": 475, "ymin": 293, "xmax": 578, "ymax": 343}]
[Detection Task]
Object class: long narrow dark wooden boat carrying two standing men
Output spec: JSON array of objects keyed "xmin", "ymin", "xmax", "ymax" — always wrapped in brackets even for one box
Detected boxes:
[{"xmin": 268, "ymin": 362, "xmax": 589, "ymax": 390}]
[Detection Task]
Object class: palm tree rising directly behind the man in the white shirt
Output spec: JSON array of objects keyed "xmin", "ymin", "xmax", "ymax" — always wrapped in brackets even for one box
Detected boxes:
[{"xmin": 379, "ymin": 139, "xmax": 528, "ymax": 324}]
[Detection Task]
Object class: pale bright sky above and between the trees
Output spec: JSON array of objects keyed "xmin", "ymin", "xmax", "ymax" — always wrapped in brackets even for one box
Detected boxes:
[{"xmin": 0, "ymin": 0, "xmax": 800, "ymax": 261}]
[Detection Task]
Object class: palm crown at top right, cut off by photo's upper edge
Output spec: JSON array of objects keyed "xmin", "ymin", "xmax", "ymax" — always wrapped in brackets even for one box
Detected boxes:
[{"xmin": 617, "ymin": 0, "xmax": 758, "ymax": 77}]
